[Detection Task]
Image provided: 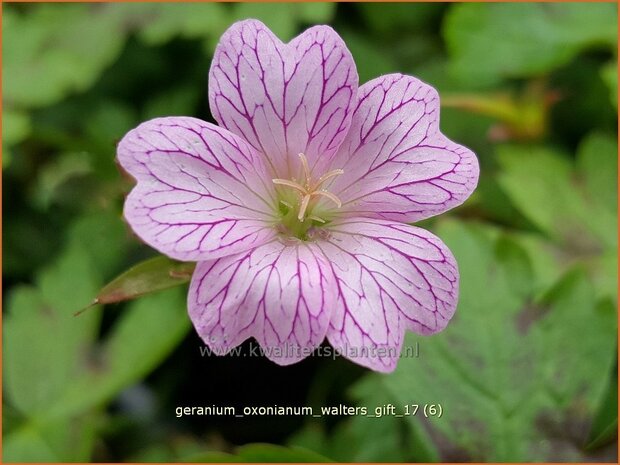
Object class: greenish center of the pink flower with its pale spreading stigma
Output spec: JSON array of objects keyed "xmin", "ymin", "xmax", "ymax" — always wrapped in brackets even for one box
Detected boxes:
[{"xmin": 272, "ymin": 153, "xmax": 344, "ymax": 239}]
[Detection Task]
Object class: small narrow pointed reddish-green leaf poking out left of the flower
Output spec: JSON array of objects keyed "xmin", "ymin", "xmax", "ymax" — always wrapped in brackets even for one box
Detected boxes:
[{"xmin": 95, "ymin": 256, "xmax": 196, "ymax": 304}]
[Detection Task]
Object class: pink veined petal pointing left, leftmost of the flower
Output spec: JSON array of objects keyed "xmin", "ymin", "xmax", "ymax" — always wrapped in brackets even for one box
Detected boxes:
[{"xmin": 118, "ymin": 117, "xmax": 275, "ymax": 261}]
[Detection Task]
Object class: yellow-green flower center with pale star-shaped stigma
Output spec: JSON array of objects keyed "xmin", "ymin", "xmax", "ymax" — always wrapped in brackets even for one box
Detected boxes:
[{"xmin": 272, "ymin": 153, "xmax": 344, "ymax": 241}]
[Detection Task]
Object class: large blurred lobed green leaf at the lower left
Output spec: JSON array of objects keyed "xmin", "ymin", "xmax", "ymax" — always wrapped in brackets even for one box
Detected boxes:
[{"xmin": 3, "ymin": 211, "xmax": 189, "ymax": 462}]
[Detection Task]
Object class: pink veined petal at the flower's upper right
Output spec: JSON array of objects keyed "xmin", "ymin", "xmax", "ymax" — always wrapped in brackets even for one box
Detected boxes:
[{"xmin": 329, "ymin": 74, "xmax": 479, "ymax": 223}]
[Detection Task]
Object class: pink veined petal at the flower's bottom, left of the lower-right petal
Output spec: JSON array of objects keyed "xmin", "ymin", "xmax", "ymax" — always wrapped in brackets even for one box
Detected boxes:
[{"xmin": 188, "ymin": 240, "xmax": 336, "ymax": 365}]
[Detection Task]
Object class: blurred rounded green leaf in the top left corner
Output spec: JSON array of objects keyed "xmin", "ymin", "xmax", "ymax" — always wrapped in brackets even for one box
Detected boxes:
[{"xmin": 2, "ymin": 4, "xmax": 126, "ymax": 108}]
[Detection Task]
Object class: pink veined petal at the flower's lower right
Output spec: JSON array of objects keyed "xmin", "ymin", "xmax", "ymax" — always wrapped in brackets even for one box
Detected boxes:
[{"xmin": 320, "ymin": 218, "xmax": 459, "ymax": 372}]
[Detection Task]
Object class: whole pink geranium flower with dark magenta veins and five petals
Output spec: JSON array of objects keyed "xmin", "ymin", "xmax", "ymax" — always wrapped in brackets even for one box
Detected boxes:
[{"xmin": 118, "ymin": 20, "xmax": 478, "ymax": 372}]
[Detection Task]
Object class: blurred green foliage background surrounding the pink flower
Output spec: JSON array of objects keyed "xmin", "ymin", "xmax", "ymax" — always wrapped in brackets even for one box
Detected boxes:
[{"xmin": 2, "ymin": 3, "xmax": 618, "ymax": 462}]
